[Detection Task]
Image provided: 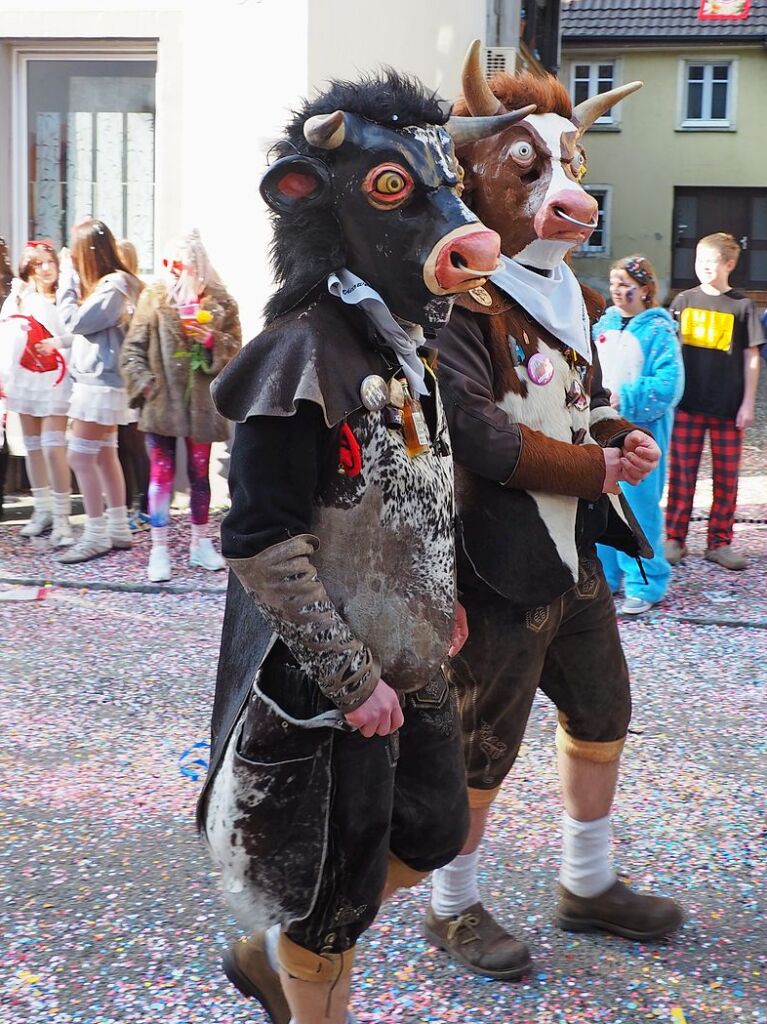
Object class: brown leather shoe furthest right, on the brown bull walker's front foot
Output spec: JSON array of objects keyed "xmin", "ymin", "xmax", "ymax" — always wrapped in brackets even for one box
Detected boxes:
[{"xmin": 556, "ymin": 881, "xmax": 684, "ymax": 941}]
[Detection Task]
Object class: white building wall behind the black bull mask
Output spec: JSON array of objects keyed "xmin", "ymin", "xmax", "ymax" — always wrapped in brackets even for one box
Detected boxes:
[{"xmin": 0, "ymin": 0, "xmax": 485, "ymax": 337}]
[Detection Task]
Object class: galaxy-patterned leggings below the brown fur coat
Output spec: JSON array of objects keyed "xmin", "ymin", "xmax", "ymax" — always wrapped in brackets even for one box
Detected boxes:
[{"xmin": 146, "ymin": 434, "xmax": 210, "ymax": 526}]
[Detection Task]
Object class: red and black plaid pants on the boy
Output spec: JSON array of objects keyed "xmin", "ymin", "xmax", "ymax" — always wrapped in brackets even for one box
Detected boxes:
[{"xmin": 666, "ymin": 409, "xmax": 743, "ymax": 549}]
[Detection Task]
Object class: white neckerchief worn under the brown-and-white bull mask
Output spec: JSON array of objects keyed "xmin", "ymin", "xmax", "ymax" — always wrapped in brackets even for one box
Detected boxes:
[{"xmin": 491, "ymin": 255, "xmax": 591, "ymax": 364}]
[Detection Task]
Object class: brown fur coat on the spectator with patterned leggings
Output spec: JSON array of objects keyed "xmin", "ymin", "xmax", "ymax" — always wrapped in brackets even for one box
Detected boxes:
[{"xmin": 121, "ymin": 282, "xmax": 243, "ymax": 443}]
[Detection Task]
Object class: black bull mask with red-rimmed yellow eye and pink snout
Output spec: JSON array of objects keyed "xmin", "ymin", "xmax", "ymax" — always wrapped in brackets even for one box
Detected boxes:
[{"xmin": 261, "ymin": 106, "xmax": 535, "ymax": 328}]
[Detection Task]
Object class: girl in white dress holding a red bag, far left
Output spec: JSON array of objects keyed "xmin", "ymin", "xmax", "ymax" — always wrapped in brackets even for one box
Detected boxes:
[{"xmin": 0, "ymin": 241, "xmax": 74, "ymax": 548}]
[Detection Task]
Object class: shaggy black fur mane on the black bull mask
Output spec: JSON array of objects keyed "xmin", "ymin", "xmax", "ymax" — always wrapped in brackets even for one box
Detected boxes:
[{"xmin": 264, "ymin": 68, "xmax": 449, "ymax": 323}]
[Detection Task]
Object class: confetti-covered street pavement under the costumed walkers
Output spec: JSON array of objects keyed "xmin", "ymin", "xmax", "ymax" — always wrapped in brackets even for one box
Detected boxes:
[{"xmin": 0, "ymin": 434, "xmax": 767, "ymax": 1024}]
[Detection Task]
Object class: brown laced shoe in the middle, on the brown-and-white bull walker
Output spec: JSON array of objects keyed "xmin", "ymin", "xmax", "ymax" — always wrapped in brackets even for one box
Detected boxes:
[{"xmin": 424, "ymin": 903, "xmax": 530, "ymax": 981}]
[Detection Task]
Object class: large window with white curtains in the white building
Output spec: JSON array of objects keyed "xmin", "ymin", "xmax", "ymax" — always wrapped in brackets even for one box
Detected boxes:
[{"xmin": 22, "ymin": 53, "xmax": 157, "ymax": 271}]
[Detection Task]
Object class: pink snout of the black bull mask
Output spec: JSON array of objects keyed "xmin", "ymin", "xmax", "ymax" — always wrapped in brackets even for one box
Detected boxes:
[{"xmin": 424, "ymin": 221, "xmax": 501, "ymax": 295}]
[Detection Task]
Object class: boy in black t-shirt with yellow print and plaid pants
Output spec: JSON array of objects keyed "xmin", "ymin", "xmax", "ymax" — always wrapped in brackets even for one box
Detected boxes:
[{"xmin": 666, "ymin": 231, "xmax": 763, "ymax": 569}]
